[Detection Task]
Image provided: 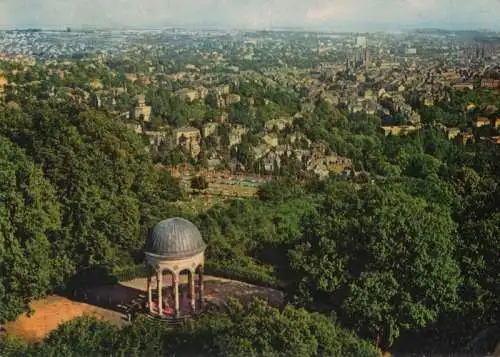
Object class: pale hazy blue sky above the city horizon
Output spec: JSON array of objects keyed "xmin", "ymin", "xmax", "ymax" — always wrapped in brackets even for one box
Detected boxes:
[{"xmin": 0, "ymin": 0, "xmax": 500, "ymax": 31}]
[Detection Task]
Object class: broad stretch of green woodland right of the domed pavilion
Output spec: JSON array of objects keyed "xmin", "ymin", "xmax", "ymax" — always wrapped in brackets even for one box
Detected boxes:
[{"xmin": 198, "ymin": 169, "xmax": 499, "ymax": 349}]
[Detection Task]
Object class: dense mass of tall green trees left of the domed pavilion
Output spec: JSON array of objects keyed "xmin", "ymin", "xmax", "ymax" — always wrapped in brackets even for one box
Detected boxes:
[{"xmin": 0, "ymin": 101, "xmax": 182, "ymax": 321}]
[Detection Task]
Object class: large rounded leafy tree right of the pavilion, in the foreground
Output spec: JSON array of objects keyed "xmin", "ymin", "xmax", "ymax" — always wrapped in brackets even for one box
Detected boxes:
[{"xmin": 290, "ymin": 185, "xmax": 460, "ymax": 347}]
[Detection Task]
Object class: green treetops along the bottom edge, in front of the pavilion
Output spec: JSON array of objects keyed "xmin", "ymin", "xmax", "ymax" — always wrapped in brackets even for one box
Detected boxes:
[{"xmin": 0, "ymin": 301, "xmax": 378, "ymax": 357}]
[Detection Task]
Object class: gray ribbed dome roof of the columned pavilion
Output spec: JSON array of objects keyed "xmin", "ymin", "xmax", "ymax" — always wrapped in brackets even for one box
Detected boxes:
[{"xmin": 146, "ymin": 218, "xmax": 207, "ymax": 259}]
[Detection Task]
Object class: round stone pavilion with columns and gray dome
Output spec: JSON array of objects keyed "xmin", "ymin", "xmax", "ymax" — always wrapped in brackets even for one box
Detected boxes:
[{"xmin": 145, "ymin": 218, "xmax": 207, "ymax": 318}]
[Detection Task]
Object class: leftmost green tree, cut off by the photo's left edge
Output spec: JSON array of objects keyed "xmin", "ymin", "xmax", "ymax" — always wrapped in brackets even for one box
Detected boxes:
[{"xmin": 0, "ymin": 136, "xmax": 61, "ymax": 323}]
